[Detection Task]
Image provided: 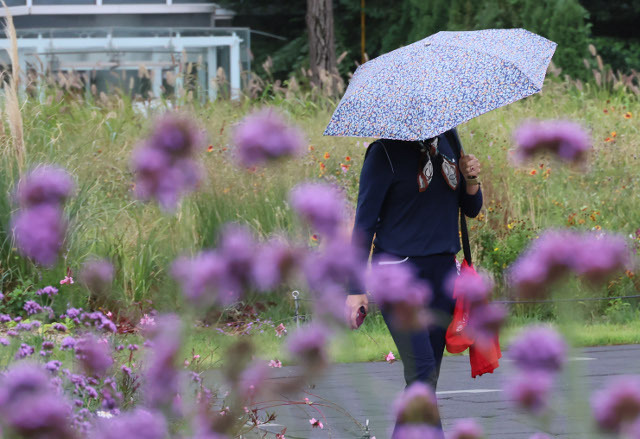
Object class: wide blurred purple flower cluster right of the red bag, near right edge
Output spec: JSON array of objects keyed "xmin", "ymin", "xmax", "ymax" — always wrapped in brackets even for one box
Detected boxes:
[{"xmin": 509, "ymin": 230, "xmax": 631, "ymax": 297}]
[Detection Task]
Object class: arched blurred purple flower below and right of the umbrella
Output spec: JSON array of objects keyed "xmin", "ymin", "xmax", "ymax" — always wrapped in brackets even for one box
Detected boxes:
[{"xmin": 513, "ymin": 120, "xmax": 591, "ymax": 162}]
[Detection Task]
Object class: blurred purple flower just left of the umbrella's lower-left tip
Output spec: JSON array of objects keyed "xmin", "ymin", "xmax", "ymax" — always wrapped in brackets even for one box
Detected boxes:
[{"xmin": 233, "ymin": 109, "xmax": 305, "ymax": 166}]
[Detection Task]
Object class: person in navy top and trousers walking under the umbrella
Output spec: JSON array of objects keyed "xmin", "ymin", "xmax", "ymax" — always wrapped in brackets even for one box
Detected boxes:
[{"xmin": 346, "ymin": 129, "xmax": 483, "ymax": 430}]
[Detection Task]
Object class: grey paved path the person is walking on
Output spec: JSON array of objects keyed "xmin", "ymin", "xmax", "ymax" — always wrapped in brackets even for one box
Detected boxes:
[{"xmin": 251, "ymin": 345, "xmax": 640, "ymax": 439}]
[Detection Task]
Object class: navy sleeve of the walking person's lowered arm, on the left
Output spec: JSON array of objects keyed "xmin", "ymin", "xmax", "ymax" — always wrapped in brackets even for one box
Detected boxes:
[{"xmin": 349, "ymin": 142, "xmax": 393, "ymax": 294}]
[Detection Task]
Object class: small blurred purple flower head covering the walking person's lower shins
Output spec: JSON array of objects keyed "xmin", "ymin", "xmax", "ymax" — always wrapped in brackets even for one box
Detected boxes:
[{"xmin": 393, "ymin": 381, "xmax": 440, "ymax": 426}]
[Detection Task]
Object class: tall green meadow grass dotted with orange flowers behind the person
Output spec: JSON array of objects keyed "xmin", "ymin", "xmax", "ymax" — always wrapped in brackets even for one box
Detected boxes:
[{"xmin": 0, "ymin": 80, "xmax": 640, "ymax": 362}]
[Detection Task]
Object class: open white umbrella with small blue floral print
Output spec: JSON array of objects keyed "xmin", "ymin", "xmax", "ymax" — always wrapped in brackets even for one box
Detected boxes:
[{"xmin": 324, "ymin": 29, "xmax": 557, "ymax": 140}]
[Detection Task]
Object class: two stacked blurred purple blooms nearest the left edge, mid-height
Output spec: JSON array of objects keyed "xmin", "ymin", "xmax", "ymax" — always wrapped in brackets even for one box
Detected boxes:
[{"xmin": 12, "ymin": 165, "xmax": 74, "ymax": 266}]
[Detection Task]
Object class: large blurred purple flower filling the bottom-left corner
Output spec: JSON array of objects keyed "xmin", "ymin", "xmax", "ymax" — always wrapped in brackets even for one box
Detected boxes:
[{"xmin": 0, "ymin": 364, "xmax": 74, "ymax": 438}]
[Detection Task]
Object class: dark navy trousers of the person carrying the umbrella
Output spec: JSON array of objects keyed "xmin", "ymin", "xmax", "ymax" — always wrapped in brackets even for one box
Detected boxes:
[{"xmin": 374, "ymin": 254, "xmax": 456, "ymax": 436}]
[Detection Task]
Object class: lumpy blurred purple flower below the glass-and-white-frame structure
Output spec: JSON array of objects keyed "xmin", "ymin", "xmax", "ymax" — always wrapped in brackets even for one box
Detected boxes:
[{"xmin": 132, "ymin": 114, "xmax": 205, "ymax": 210}]
